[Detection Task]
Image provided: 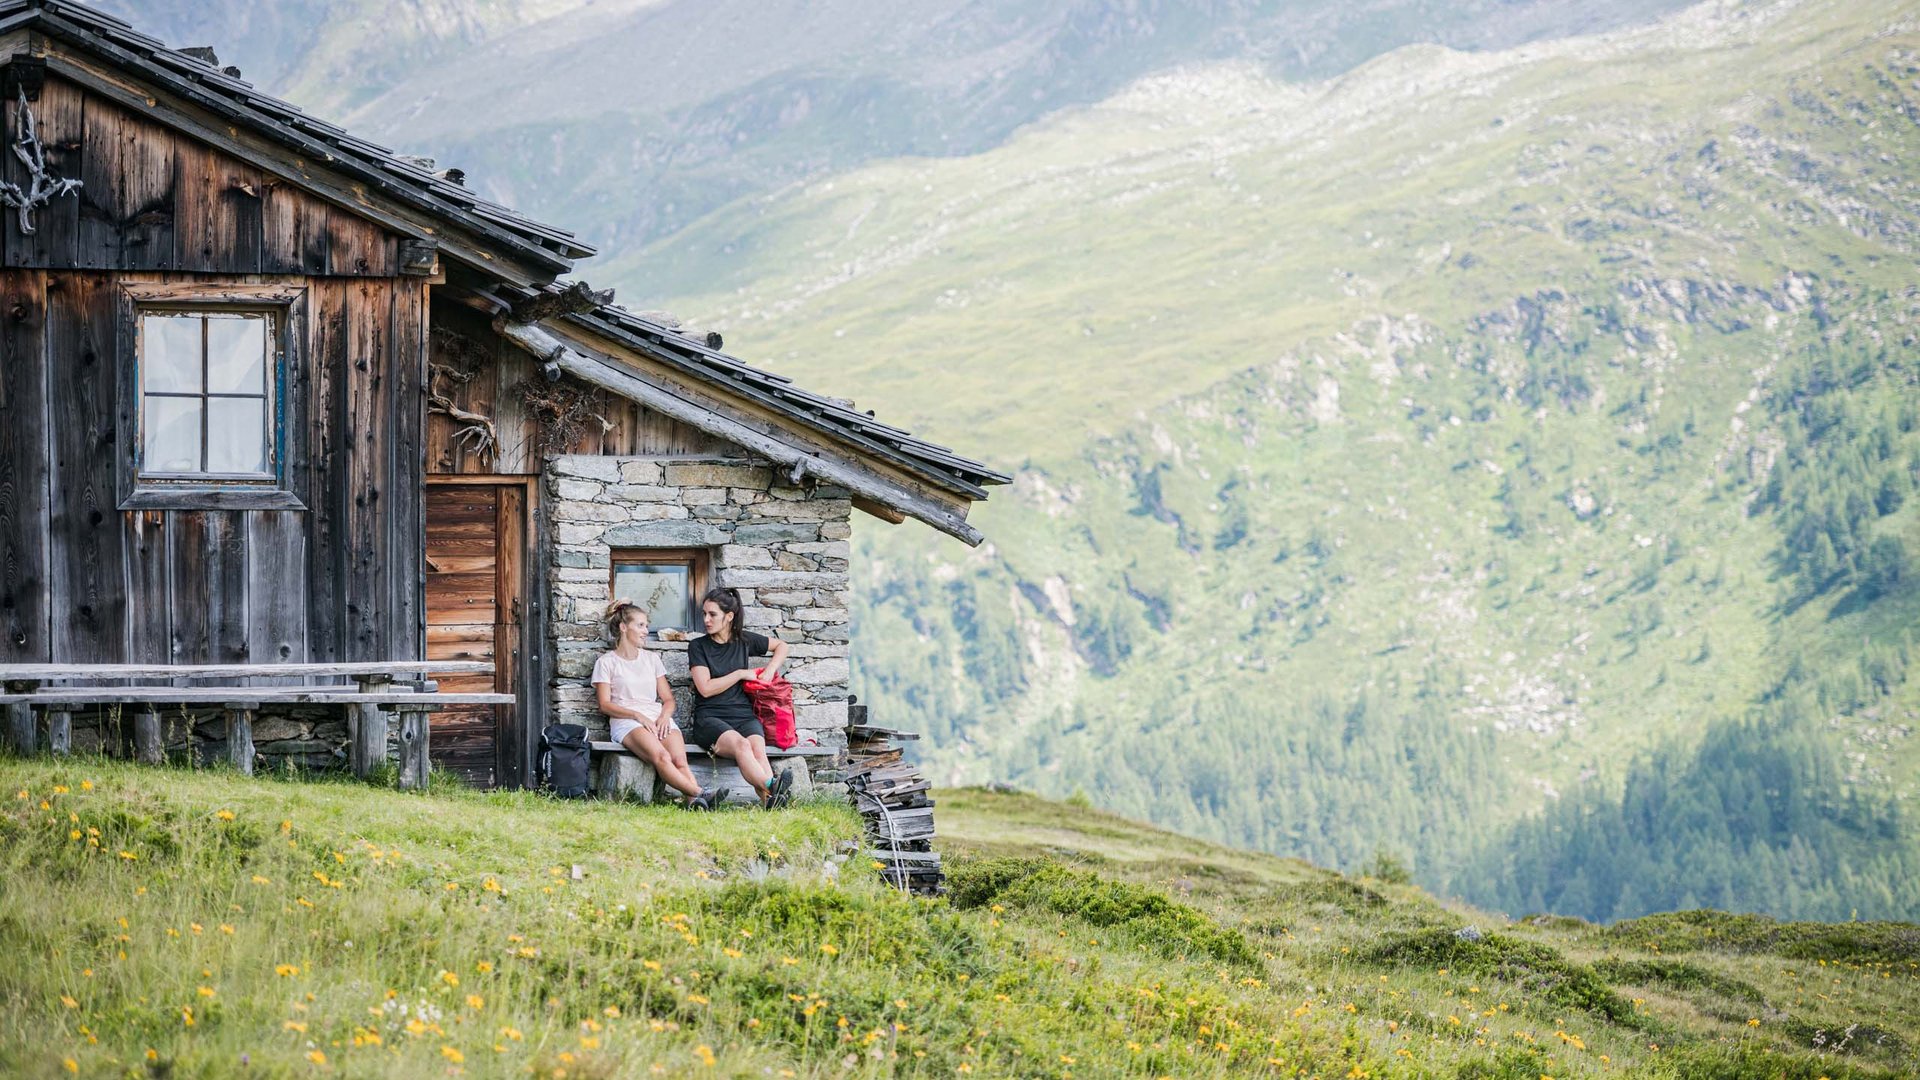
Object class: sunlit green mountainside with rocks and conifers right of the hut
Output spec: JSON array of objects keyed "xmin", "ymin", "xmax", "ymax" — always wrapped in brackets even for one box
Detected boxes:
[{"xmin": 625, "ymin": 0, "xmax": 1920, "ymax": 919}]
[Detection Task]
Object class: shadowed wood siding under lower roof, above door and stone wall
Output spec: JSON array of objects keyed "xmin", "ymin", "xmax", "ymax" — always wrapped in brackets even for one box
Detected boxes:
[{"xmin": 426, "ymin": 304, "xmax": 737, "ymax": 477}]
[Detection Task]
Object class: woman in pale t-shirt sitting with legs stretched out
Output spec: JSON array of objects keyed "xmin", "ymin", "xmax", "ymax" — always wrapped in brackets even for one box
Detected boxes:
[{"xmin": 593, "ymin": 600, "xmax": 712, "ymax": 809}]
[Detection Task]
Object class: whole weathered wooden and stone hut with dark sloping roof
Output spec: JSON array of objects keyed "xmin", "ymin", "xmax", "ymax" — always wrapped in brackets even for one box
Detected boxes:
[{"xmin": 0, "ymin": 0, "xmax": 1006, "ymax": 786}]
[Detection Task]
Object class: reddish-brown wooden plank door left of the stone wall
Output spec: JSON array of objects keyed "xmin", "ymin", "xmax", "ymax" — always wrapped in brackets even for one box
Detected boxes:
[{"xmin": 426, "ymin": 482, "xmax": 526, "ymax": 788}]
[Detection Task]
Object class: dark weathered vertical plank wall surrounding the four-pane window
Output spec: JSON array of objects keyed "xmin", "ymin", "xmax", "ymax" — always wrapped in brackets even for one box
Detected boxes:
[{"xmin": 0, "ymin": 269, "xmax": 426, "ymax": 663}]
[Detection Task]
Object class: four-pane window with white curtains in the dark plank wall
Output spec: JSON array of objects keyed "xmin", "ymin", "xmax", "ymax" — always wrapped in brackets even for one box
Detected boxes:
[{"xmin": 136, "ymin": 306, "xmax": 280, "ymax": 484}]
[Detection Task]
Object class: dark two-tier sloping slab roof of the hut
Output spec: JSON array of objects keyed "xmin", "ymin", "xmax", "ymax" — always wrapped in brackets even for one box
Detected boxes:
[{"xmin": 0, "ymin": 0, "xmax": 1010, "ymax": 544}]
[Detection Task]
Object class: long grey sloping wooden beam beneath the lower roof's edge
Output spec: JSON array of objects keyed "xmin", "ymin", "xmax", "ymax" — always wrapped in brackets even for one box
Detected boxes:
[{"xmin": 495, "ymin": 321, "xmax": 985, "ymax": 546}]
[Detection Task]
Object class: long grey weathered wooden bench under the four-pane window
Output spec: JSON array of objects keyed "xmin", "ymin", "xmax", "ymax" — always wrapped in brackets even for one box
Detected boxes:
[{"xmin": 0, "ymin": 661, "xmax": 515, "ymax": 788}]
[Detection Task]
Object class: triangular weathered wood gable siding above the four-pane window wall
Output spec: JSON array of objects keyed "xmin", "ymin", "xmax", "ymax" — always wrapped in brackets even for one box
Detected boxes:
[{"xmin": 0, "ymin": 77, "xmax": 399, "ymax": 277}]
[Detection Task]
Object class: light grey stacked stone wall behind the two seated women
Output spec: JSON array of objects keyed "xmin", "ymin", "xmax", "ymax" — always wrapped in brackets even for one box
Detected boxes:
[{"xmin": 543, "ymin": 455, "xmax": 852, "ymax": 746}]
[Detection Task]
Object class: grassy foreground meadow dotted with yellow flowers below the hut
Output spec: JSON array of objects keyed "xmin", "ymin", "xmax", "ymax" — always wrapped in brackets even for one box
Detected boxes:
[{"xmin": 0, "ymin": 759, "xmax": 1920, "ymax": 1080}]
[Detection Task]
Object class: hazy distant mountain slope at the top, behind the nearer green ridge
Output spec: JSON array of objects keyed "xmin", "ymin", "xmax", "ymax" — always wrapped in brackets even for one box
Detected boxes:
[{"xmin": 111, "ymin": 0, "xmax": 1678, "ymax": 250}]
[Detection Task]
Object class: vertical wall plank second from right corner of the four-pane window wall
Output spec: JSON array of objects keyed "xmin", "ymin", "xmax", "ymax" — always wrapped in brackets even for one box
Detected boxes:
[{"xmin": 338, "ymin": 281, "xmax": 392, "ymax": 661}]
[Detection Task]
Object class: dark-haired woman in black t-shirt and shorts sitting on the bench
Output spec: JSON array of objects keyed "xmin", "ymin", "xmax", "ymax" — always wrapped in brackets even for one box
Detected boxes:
[{"xmin": 687, "ymin": 588, "xmax": 793, "ymax": 809}]
